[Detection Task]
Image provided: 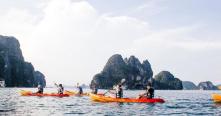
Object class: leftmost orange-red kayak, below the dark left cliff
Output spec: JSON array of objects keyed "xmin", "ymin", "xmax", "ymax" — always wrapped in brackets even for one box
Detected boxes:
[{"xmin": 20, "ymin": 90, "xmax": 70, "ymax": 97}]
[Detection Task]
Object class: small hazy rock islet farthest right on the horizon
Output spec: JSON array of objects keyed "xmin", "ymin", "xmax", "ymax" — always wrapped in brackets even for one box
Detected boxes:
[{"xmin": 198, "ymin": 81, "xmax": 218, "ymax": 90}]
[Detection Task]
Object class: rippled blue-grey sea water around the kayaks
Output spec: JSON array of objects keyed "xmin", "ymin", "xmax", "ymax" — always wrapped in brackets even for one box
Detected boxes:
[{"xmin": 0, "ymin": 88, "xmax": 221, "ymax": 116}]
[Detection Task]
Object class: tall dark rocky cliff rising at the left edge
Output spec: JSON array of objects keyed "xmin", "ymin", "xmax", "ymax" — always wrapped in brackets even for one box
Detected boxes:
[{"xmin": 0, "ymin": 35, "xmax": 45, "ymax": 87}]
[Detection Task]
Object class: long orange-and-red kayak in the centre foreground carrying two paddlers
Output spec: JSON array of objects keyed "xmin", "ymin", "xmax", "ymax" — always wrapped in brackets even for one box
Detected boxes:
[{"xmin": 90, "ymin": 93, "xmax": 165, "ymax": 103}]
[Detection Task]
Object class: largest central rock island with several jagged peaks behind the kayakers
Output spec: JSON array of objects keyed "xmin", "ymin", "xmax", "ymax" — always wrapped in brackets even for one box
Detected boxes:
[{"xmin": 91, "ymin": 54, "xmax": 153, "ymax": 89}]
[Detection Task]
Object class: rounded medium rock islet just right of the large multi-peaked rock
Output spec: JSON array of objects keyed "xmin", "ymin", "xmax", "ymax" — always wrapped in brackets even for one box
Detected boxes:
[{"xmin": 154, "ymin": 71, "xmax": 183, "ymax": 90}]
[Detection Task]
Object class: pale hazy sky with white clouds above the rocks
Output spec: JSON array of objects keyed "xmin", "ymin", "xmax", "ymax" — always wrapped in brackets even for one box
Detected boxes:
[{"xmin": 0, "ymin": 0, "xmax": 221, "ymax": 85}]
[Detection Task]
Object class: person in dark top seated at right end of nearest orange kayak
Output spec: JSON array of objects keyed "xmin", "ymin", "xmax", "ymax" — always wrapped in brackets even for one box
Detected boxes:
[{"xmin": 139, "ymin": 83, "xmax": 154, "ymax": 99}]
